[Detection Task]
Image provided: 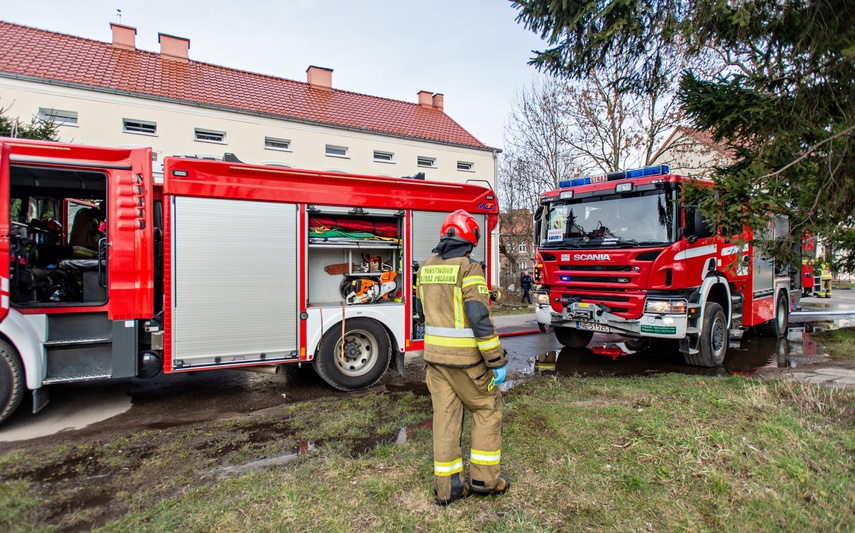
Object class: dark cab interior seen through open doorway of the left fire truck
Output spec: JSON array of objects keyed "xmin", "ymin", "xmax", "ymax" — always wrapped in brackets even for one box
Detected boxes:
[{"xmin": 8, "ymin": 164, "xmax": 107, "ymax": 307}]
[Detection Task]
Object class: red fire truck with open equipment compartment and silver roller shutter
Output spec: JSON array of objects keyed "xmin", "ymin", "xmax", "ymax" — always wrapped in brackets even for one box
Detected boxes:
[{"xmin": 0, "ymin": 139, "xmax": 498, "ymax": 421}]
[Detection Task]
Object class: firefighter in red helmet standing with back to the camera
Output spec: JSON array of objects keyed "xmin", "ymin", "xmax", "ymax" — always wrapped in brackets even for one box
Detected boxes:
[{"xmin": 418, "ymin": 209, "xmax": 510, "ymax": 505}]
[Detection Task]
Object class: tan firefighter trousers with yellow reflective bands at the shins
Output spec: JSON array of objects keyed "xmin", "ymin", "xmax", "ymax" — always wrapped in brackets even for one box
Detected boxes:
[{"xmin": 425, "ymin": 363, "xmax": 502, "ymax": 500}]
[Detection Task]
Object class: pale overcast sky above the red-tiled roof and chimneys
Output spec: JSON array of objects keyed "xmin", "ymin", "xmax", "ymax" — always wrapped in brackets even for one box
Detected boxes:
[{"xmin": 0, "ymin": 0, "xmax": 545, "ymax": 148}]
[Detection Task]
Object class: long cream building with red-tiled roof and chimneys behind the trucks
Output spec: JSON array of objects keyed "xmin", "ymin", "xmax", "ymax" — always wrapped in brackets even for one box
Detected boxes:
[{"xmin": 0, "ymin": 22, "xmax": 497, "ymax": 186}]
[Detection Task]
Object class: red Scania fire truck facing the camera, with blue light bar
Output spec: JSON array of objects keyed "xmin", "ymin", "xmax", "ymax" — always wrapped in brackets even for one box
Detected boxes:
[{"xmin": 534, "ymin": 165, "xmax": 800, "ymax": 367}]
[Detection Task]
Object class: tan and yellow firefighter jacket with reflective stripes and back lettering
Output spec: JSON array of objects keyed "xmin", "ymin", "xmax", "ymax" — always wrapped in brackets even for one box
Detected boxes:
[{"xmin": 418, "ymin": 255, "xmax": 507, "ymax": 368}]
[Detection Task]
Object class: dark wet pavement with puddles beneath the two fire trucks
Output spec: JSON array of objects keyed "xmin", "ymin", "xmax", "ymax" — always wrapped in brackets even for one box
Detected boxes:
[{"xmin": 0, "ymin": 290, "xmax": 855, "ymax": 442}]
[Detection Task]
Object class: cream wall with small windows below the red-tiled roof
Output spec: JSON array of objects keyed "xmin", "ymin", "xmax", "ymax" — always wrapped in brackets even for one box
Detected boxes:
[{"xmin": 0, "ymin": 78, "xmax": 495, "ymax": 188}]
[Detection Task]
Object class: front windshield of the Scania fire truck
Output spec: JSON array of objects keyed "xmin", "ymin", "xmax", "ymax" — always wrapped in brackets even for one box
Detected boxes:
[{"xmin": 539, "ymin": 190, "xmax": 675, "ymax": 248}]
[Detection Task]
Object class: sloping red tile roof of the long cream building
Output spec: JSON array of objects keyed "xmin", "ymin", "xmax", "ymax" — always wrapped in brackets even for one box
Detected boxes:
[{"xmin": 0, "ymin": 21, "xmax": 487, "ymax": 149}]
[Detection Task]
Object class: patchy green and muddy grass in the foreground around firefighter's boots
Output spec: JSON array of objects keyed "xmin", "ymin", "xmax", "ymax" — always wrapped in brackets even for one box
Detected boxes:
[{"xmin": 0, "ymin": 374, "xmax": 855, "ymax": 532}]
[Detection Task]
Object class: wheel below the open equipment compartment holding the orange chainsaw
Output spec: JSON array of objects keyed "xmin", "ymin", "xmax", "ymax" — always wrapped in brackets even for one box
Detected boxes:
[{"xmin": 312, "ymin": 318, "xmax": 391, "ymax": 391}]
